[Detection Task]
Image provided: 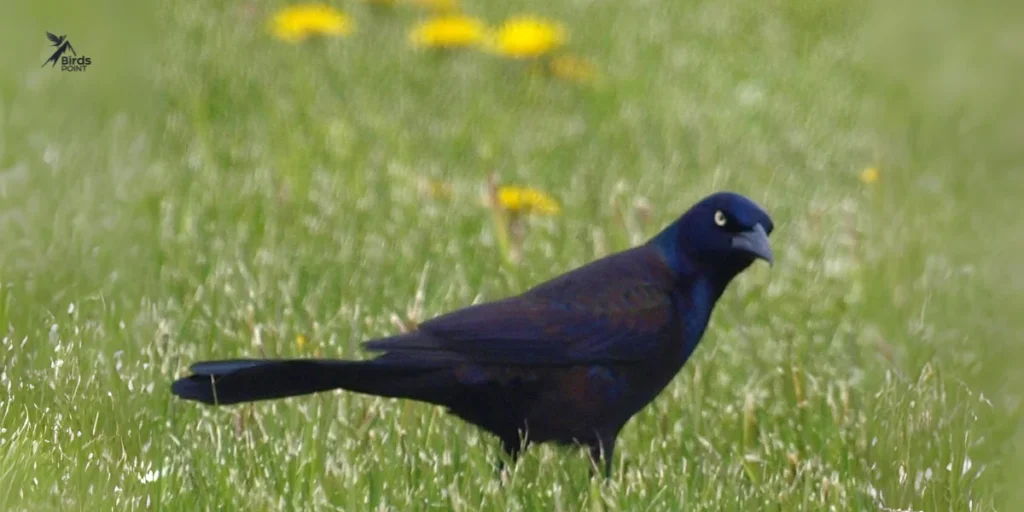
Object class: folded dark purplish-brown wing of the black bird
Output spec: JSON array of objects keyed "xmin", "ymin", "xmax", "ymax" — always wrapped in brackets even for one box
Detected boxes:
[{"xmin": 367, "ymin": 246, "xmax": 677, "ymax": 366}]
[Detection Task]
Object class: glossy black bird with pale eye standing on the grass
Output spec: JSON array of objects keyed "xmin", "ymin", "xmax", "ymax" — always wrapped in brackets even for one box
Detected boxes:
[{"xmin": 171, "ymin": 193, "xmax": 773, "ymax": 476}]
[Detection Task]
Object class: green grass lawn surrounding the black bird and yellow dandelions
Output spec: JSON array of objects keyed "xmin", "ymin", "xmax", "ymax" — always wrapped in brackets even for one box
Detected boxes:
[{"xmin": 0, "ymin": 0, "xmax": 1024, "ymax": 511}]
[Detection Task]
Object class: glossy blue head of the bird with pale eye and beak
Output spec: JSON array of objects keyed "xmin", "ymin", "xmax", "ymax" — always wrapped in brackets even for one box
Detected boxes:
[{"xmin": 651, "ymin": 193, "xmax": 775, "ymax": 281}]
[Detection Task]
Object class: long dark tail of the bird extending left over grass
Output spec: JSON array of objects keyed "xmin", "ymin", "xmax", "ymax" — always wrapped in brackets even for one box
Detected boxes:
[{"xmin": 171, "ymin": 356, "xmax": 455, "ymax": 404}]
